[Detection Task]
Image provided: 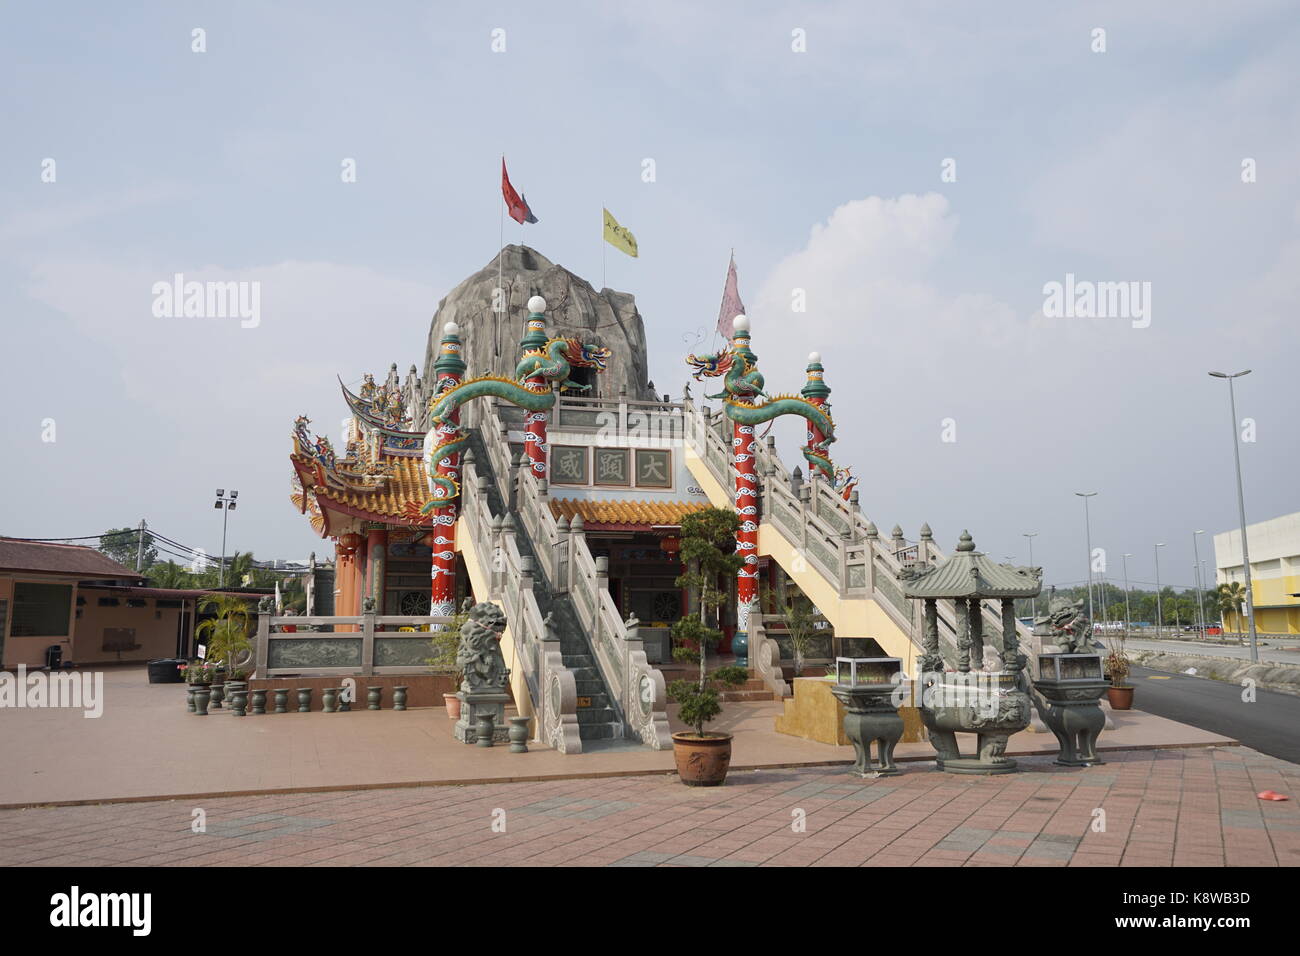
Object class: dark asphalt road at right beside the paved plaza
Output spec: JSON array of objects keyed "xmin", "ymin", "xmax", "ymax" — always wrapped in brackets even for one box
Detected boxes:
[{"xmin": 1132, "ymin": 667, "xmax": 1300, "ymax": 764}]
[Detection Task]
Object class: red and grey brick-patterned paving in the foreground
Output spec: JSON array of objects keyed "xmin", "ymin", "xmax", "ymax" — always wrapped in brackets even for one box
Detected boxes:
[{"xmin": 0, "ymin": 747, "xmax": 1300, "ymax": 866}]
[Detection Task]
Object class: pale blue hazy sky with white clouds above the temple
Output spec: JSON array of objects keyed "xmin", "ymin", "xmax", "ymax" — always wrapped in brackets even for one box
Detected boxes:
[{"xmin": 0, "ymin": 0, "xmax": 1300, "ymax": 598}]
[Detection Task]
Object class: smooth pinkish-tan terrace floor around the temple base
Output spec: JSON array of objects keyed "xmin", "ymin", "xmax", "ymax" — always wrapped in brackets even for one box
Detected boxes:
[{"xmin": 0, "ymin": 667, "xmax": 1229, "ymax": 806}]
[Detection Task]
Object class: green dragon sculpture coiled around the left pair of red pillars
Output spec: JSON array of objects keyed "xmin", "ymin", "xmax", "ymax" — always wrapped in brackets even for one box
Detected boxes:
[{"xmin": 420, "ymin": 338, "xmax": 611, "ymax": 504}]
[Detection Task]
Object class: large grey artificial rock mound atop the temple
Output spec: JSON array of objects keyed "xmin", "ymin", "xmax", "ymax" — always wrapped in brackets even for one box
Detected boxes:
[{"xmin": 420, "ymin": 245, "xmax": 655, "ymax": 421}]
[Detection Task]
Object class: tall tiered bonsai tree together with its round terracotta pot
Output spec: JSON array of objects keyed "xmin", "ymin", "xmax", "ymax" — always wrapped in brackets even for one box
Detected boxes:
[{"xmin": 668, "ymin": 507, "xmax": 749, "ymax": 787}]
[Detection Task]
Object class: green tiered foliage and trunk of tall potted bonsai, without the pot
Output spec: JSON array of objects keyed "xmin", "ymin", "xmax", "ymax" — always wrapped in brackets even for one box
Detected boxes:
[{"xmin": 668, "ymin": 507, "xmax": 749, "ymax": 737}]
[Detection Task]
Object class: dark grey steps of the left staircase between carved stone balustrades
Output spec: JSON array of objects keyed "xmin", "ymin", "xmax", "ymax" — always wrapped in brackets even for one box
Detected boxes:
[{"xmin": 469, "ymin": 429, "xmax": 623, "ymax": 745}]
